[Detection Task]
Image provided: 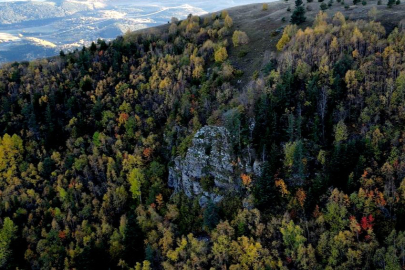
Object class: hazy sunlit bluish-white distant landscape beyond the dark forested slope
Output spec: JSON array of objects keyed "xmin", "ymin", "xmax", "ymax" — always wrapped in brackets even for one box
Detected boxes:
[{"xmin": 0, "ymin": 0, "xmax": 262, "ymax": 63}]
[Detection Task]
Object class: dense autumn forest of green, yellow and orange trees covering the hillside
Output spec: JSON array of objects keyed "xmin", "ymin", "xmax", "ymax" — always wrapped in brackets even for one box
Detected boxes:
[{"xmin": 0, "ymin": 2, "xmax": 405, "ymax": 270}]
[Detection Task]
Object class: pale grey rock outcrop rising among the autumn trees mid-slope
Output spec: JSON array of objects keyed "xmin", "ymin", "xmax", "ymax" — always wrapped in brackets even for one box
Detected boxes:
[{"xmin": 169, "ymin": 126, "xmax": 240, "ymax": 206}]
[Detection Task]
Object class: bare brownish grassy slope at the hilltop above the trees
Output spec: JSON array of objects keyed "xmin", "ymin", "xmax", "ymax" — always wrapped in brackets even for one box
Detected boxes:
[{"xmin": 138, "ymin": 0, "xmax": 405, "ymax": 85}]
